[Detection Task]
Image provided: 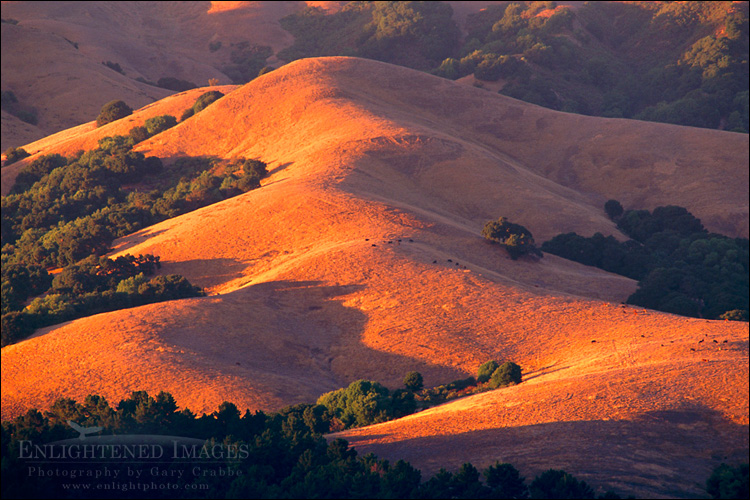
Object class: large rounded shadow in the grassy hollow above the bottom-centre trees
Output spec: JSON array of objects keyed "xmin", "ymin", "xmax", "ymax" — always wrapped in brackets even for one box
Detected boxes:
[{"xmin": 154, "ymin": 281, "xmax": 463, "ymax": 410}]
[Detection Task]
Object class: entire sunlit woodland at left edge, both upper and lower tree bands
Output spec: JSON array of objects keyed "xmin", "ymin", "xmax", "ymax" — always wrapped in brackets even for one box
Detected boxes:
[{"xmin": 2, "ymin": 123, "xmax": 267, "ymax": 345}]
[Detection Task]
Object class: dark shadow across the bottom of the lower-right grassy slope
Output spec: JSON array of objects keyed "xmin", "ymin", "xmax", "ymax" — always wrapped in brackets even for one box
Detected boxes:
[{"xmin": 336, "ymin": 404, "xmax": 748, "ymax": 498}]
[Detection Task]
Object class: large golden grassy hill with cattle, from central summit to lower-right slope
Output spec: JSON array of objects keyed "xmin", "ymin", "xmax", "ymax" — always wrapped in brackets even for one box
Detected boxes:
[{"xmin": 2, "ymin": 58, "xmax": 748, "ymax": 496}]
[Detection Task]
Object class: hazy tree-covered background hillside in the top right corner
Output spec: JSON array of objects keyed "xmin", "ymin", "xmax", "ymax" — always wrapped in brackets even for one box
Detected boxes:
[{"xmin": 458, "ymin": 2, "xmax": 748, "ymax": 133}]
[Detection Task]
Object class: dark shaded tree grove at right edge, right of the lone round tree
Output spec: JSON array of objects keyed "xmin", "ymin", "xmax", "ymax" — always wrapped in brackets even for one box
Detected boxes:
[{"xmin": 542, "ymin": 200, "xmax": 750, "ymax": 321}]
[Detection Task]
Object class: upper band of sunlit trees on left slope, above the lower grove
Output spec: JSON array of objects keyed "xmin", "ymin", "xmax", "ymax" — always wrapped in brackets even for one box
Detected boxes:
[{"xmin": 2, "ymin": 132, "xmax": 266, "ymax": 267}]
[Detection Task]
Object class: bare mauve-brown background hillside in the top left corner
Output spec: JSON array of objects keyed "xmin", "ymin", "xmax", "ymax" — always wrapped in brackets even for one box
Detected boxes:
[{"xmin": 2, "ymin": 2, "xmax": 304, "ymax": 151}]
